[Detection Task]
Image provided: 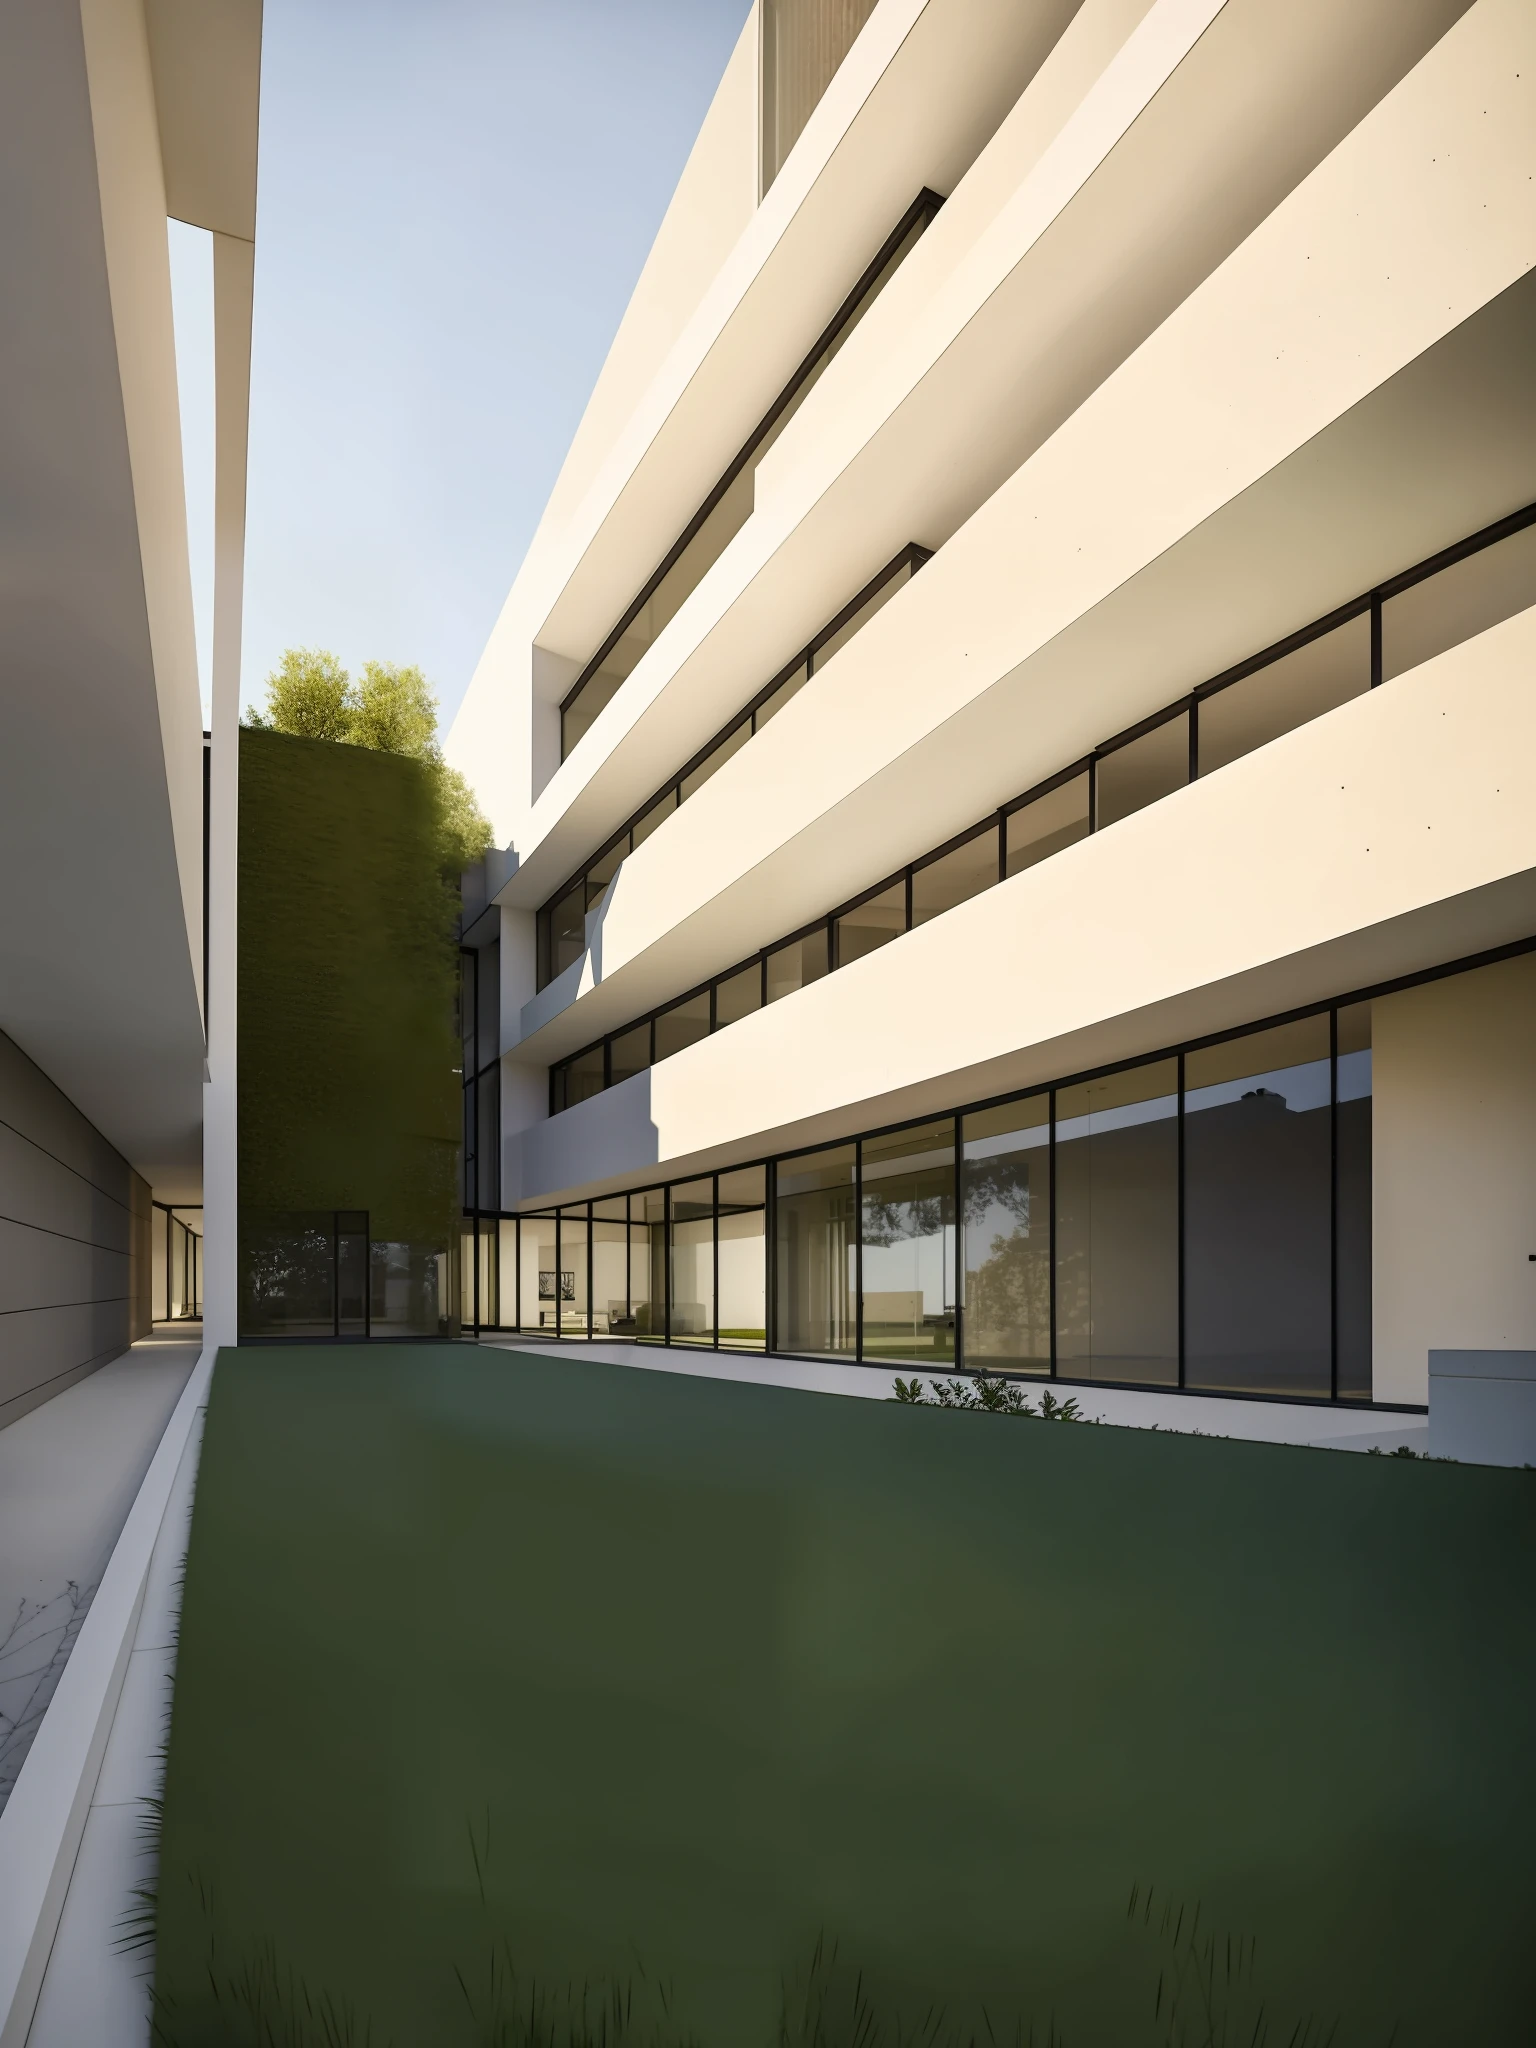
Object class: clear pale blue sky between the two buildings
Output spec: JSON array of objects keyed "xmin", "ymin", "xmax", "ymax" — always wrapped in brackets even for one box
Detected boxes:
[{"xmin": 172, "ymin": 0, "xmax": 748, "ymax": 731}]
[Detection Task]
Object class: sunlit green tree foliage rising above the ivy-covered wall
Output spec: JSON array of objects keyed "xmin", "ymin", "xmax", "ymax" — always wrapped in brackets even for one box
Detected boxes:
[{"xmin": 246, "ymin": 647, "xmax": 492, "ymax": 877}]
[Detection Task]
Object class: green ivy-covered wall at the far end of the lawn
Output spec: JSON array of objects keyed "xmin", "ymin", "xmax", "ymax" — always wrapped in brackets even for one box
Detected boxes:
[{"xmin": 238, "ymin": 729, "xmax": 461, "ymax": 1321}]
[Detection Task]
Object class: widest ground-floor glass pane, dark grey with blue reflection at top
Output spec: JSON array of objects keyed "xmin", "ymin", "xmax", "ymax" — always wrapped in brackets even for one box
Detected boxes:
[{"xmin": 1184, "ymin": 1016, "xmax": 1333, "ymax": 1395}]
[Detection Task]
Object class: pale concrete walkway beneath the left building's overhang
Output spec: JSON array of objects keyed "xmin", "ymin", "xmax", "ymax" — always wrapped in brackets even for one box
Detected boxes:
[{"xmin": 0, "ymin": 1323, "xmax": 203, "ymax": 1808}]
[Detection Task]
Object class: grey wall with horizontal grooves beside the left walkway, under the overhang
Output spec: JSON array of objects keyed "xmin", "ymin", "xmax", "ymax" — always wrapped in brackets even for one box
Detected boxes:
[{"xmin": 0, "ymin": 1032, "xmax": 150, "ymax": 1425}]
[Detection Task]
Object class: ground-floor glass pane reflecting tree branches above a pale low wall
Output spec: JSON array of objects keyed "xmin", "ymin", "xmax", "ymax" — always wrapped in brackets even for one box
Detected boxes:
[{"xmin": 860, "ymin": 1116, "xmax": 956, "ymax": 1366}]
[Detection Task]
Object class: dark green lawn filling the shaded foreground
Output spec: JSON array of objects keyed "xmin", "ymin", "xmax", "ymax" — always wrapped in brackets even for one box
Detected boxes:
[{"xmin": 156, "ymin": 1346, "xmax": 1536, "ymax": 2048}]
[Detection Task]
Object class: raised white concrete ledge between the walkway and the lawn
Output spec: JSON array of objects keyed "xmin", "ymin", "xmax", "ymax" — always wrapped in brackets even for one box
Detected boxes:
[{"xmin": 0, "ymin": 1350, "xmax": 213, "ymax": 2048}]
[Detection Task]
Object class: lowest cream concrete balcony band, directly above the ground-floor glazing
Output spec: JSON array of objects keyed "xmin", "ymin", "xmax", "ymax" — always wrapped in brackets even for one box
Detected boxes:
[{"xmin": 512, "ymin": 593, "xmax": 1536, "ymax": 1202}]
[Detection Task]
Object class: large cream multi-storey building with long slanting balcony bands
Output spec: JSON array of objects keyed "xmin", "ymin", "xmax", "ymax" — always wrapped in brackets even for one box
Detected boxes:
[{"xmin": 449, "ymin": 0, "xmax": 1536, "ymax": 1442}]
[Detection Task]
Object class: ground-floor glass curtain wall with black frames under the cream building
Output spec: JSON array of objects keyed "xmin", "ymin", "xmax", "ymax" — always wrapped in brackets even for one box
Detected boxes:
[{"xmin": 489, "ymin": 983, "xmax": 1372, "ymax": 1401}]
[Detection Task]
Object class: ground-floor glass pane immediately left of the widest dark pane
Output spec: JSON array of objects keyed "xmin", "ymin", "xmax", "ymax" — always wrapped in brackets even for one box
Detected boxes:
[{"xmin": 1055, "ymin": 1059, "xmax": 1180, "ymax": 1386}]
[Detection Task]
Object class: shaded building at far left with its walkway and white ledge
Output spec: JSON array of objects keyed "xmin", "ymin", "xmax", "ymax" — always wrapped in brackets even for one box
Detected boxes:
[{"xmin": 0, "ymin": 0, "xmax": 262, "ymax": 2048}]
